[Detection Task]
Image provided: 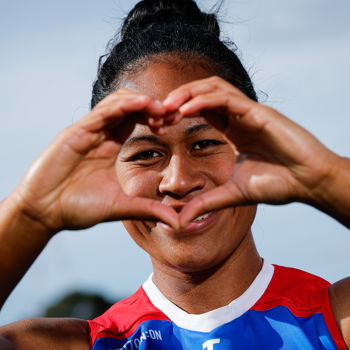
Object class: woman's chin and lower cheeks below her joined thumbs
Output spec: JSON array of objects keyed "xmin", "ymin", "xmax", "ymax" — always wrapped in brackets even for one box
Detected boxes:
[{"xmin": 123, "ymin": 207, "xmax": 255, "ymax": 273}]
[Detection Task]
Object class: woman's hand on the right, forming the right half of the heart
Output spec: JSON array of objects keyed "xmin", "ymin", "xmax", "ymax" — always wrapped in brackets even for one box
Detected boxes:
[{"xmin": 164, "ymin": 77, "xmax": 335, "ymax": 227}]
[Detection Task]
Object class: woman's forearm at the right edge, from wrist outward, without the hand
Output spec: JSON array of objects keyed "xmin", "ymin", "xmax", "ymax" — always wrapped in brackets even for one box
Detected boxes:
[{"xmin": 311, "ymin": 156, "xmax": 350, "ymax": 228}]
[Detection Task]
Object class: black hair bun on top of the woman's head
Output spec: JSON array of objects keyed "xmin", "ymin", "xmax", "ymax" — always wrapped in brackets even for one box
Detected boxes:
[{"xmin": 121, "ymin": 0, "xmax": 220, "ymax": 40}]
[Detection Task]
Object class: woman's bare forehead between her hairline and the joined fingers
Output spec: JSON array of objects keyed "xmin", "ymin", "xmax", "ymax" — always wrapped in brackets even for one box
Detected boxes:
[{"xmin": 119, "ymin": 58, "xmax": 212, "ymax": 101}]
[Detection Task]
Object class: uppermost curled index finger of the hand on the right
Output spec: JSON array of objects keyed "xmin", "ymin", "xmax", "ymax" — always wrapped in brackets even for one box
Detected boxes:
[{"xmin": 163, "ymin": 77, "xmax": 245, "ymax": 111}]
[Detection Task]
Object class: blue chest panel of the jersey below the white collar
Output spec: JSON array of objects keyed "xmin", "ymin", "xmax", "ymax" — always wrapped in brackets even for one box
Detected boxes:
[{"xmin": 93, "ymin": 306, "xmax": 337, "ymax": 350}]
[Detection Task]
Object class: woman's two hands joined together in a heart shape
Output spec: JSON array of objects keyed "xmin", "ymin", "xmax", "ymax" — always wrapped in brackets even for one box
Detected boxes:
[{"xmin": 24, "ymin": 77, "xmax": 315, "ymax": 232}]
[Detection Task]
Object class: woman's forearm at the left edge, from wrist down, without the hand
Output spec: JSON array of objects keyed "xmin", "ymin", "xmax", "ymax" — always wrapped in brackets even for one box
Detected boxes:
[{"xmin": 0, "ymin": 196, "xmax": 50, "ymax": 306}]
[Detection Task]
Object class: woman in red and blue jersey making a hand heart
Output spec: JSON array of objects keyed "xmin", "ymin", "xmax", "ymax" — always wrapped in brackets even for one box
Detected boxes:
[{"xmin": 0, "ymin": 0, "xmax": 350, "ymax": 350}]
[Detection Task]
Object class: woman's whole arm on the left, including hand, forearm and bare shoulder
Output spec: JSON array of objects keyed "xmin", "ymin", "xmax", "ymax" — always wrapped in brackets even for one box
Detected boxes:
[{"xmin": 0, "ymin": 89, "xmax": 178, "ymax": 344}]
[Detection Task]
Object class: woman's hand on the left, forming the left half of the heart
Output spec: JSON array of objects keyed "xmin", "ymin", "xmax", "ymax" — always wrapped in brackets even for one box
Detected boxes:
[{"xmin": 8, "ymin": 89, "xmax": 178, "ymax": 233}]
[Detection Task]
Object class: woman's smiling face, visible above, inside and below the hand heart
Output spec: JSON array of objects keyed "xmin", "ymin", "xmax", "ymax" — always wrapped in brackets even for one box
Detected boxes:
[{"xmin": 116, "ymin": 62, "xmax": 256, "ymax": 272}]
